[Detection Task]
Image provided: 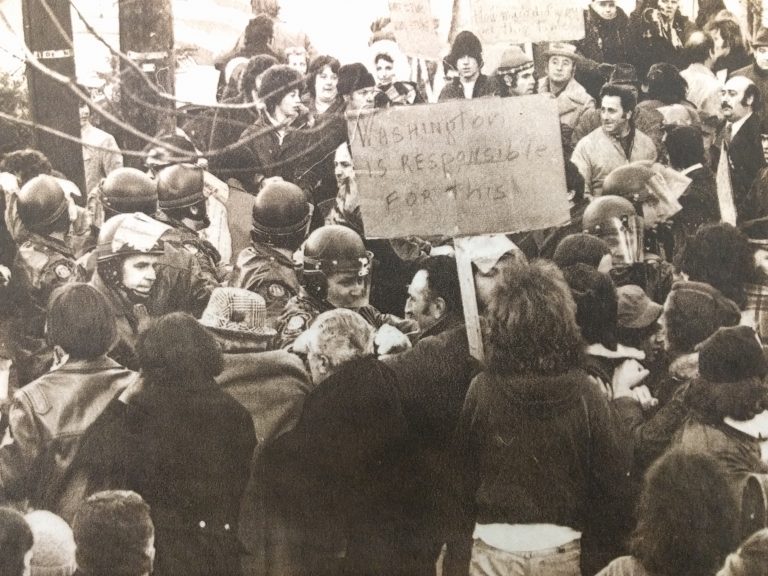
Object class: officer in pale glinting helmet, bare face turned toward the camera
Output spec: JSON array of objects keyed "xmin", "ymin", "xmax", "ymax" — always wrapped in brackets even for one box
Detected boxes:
[{"xmin": 91, "ymin": 213, "xmax": 171, "ymax": 370}]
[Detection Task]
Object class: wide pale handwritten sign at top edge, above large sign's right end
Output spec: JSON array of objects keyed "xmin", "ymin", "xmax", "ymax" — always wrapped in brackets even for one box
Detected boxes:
[{"xmin": 472, "ymin": 0, "xmax": 587, "ymax": 43}]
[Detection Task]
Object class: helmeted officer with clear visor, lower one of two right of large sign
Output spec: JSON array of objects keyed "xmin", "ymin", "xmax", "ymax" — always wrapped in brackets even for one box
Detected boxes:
[{"xmin": 582, "ymin": 196, "xmax": 673, "ymax": 304}]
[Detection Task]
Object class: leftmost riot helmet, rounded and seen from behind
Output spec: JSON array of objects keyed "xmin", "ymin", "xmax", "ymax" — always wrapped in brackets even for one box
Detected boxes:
[{"xmin": 16, "ymin": 174, "xmax": 69, "ymax": 234}]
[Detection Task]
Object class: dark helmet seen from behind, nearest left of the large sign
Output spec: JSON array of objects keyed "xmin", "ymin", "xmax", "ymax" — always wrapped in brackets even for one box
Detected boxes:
[{"xmin": 251, "ymin": 180, "xmax": 314, "ymax": 252}]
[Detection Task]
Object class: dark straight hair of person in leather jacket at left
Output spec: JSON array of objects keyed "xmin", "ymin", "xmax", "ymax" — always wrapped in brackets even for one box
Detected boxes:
[{"xmin": 46, "ymin": 282, "xmax": 117, "ymax": 360}]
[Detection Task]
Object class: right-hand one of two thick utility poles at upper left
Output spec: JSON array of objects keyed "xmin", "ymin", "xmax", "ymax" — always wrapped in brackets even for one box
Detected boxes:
[{"xmin": 118, "ymin": 0, "xmax": 176, "ymax": 168}]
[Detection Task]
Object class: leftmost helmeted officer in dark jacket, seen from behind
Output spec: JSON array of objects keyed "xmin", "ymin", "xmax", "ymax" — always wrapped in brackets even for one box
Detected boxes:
[{"xmin": 11, "ymin": 175, "xmax": 85, "ymax": 385}]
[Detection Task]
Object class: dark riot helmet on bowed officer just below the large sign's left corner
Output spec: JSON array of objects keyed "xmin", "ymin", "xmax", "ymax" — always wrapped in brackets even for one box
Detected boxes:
[{"xmin": 301, "ymin": 224, "xmax": 373, "ymax": 300}]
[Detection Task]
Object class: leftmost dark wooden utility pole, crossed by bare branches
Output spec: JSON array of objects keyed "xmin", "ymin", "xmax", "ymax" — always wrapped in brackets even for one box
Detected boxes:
[{"xmin": 22, "ymin": 0, "xmax": 85, "ymax": 195}]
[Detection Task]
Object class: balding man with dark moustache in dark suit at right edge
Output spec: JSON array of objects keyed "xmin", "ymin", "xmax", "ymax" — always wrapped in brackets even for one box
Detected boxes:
[{"xmin": 718, "ymin": 76, "xmax": 766, "ymax": 220}]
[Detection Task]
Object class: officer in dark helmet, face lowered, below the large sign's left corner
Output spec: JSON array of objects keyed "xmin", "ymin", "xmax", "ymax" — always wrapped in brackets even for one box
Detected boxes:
[{"xmin": 277, "ymin": 225, "xmax": 418, "ymax": 353}]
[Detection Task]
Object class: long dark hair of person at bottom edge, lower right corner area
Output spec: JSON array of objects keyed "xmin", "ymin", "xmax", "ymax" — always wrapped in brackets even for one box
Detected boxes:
[{"xmin": 630, "ymin": 449, "xmax": 740, "ymax": 576}]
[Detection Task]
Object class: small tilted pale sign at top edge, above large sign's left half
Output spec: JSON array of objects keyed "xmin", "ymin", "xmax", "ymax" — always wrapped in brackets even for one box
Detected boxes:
[{"xmin": 389, "ymin": 0, "xmax": 443, "ymax": 60}]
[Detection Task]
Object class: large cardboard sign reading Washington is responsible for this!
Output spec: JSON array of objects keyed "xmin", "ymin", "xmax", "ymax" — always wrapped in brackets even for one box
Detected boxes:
[{"xmin": 349, "ymin": 94, "xmax": 569, "ymax": 238}]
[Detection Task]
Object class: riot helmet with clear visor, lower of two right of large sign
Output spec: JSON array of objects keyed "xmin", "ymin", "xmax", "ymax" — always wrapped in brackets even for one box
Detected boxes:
[{"xmin": 582, "ymin": 196, "xmax": 643, "ymax": 267}]
